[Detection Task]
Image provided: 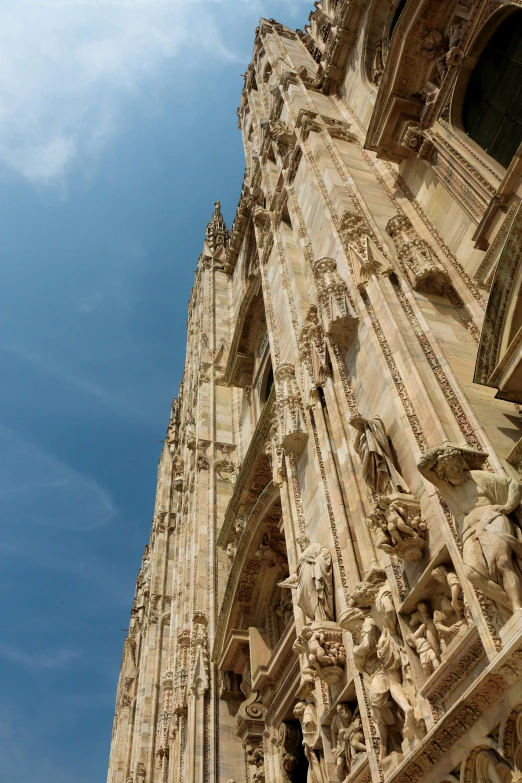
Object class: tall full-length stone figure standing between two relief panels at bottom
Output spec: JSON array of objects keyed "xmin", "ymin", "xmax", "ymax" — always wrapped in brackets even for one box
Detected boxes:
[{"xmin": 341, "ymin": 565, "xmax": 425, "ymax": 766}]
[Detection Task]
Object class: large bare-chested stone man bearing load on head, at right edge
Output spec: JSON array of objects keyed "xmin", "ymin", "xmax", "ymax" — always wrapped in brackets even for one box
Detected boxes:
[{"xmin": 417, "ymin": 443, "xmax": 522, "ymax": 620}]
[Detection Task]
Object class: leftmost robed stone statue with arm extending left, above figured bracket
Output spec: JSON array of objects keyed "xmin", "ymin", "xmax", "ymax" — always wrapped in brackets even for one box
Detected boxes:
[{"xmin": 279, "ymin": 535, "xmax": 334, "ymax": 622}]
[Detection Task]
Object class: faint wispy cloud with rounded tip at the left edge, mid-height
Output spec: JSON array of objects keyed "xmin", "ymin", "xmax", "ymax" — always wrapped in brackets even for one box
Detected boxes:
[{"xmin": 0, "ymin": 426, "xmax": 118, "ymax": 530}]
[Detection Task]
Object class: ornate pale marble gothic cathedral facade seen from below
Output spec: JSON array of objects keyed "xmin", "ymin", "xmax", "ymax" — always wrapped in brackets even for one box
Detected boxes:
[{"xmin": 108, "ymin": 0, "xmax": 522, "ymax": 783}]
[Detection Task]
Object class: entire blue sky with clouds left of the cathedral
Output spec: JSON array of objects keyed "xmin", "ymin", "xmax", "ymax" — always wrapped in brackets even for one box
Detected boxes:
[{"xmin": 0, "ymin": 0, "xmax": 312, "ymax": 783}]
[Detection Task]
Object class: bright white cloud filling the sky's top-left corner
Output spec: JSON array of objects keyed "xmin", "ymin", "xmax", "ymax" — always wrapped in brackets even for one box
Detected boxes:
[{"xmin": 0, "ymin": 0, "xmax": 248, "ymax": 186}]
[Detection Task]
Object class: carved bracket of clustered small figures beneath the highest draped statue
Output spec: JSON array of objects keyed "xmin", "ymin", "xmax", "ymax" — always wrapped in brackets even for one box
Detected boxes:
[{"xmin": 366, "ymin": 492, "xmax": 427, "ymax": 562}]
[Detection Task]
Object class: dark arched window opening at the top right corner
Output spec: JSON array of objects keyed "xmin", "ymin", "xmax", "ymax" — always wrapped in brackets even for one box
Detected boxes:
[{"xmin": 462, "ymin": 11, "xmax": 522, "ymax": 168}]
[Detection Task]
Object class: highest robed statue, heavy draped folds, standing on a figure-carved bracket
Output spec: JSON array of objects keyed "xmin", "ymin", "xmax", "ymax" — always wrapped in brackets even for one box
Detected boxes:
[{"xmin": 350, "ymin": 416, "xmax": 408, "ymax": 495}]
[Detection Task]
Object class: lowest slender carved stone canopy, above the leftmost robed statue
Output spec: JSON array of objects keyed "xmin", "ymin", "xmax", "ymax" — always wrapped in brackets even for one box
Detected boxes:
[{"xmin": 274, "ymin": 364, "xmax": 308, "ymax": 456}]
